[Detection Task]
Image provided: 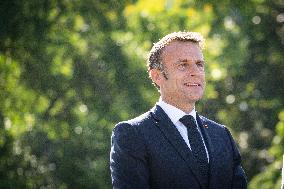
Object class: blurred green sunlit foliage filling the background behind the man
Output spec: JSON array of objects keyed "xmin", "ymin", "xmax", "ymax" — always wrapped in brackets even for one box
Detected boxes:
[{"xmin": 0, "ymin": 0, "xmax": 284, "ymax": 189}]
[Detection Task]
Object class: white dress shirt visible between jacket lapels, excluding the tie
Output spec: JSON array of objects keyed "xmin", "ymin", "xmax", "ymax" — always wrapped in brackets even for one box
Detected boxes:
[{"xmin": 157, "ymin": 98, "xmax": 209, "ymax": 162}]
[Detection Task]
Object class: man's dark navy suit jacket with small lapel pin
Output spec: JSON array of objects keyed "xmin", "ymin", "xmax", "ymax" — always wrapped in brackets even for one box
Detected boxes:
[{"xmin": 110, "ymin": 105, "xmax": 247, "ymax": 189}]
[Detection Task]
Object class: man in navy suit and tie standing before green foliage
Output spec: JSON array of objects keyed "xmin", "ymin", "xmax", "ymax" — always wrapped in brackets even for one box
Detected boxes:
[{"xmin": 110, "ymin": 32, "xmax": 247, "ymax": 189}]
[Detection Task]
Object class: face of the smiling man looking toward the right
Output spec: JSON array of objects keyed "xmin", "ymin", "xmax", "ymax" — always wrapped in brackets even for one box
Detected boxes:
[{"xmin": 152, "ymin": 41, "xmax": 205, "ymax": 107}]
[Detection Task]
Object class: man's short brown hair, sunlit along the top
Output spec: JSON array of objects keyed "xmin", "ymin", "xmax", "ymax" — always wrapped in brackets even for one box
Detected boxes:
[{"xmin": 147, "ymin": 31, "xmax": 204, "ymax": 71}]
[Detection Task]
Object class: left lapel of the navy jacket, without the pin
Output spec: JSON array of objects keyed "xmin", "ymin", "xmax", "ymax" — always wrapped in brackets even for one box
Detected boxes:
[{"xmin": 151, "ymin": 105, "xmax": 206, "ymax": 188}]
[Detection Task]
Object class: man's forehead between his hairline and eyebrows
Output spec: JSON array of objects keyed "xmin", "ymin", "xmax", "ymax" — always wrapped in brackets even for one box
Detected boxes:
[{"xmin": 161, "ymin": 41, "xmax": 203, "ymax": 60}]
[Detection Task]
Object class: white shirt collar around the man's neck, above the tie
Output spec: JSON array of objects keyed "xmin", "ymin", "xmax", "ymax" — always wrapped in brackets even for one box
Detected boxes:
[{"xmin": 157, "ymin": 98, "xmax": 196, "ymax": 124}]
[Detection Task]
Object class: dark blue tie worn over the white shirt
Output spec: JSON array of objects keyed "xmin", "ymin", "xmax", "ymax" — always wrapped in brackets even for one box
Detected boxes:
[{"xmin": 180, "ymin": 115, "xmax": 209, "ymax": 180}]
